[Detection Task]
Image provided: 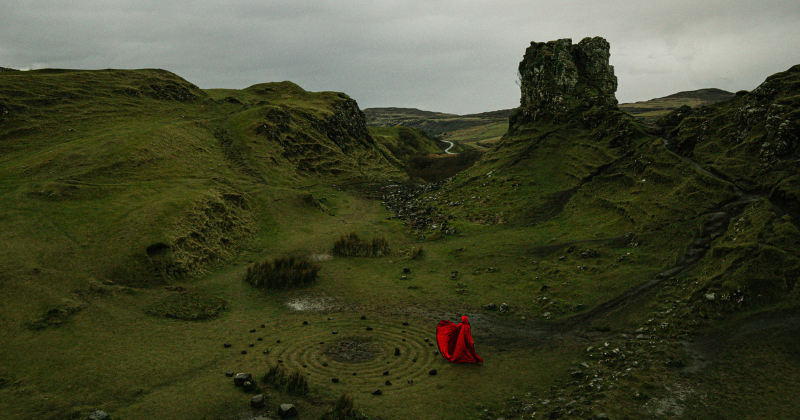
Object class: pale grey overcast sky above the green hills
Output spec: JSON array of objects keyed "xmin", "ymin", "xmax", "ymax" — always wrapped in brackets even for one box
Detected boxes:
[{"xmin": 0, "ymin": 0, "xmax": 800, "ymax": 114}]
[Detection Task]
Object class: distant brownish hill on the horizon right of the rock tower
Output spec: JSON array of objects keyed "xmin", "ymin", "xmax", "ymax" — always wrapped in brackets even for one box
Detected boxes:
[{"xmin": 619, "ymin": 88, "xmax": 734, "ymax": 122}]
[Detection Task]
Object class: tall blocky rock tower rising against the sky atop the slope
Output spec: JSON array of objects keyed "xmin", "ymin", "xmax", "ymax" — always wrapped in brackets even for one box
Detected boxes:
[{"xmin": 511, "ymin": 37, "xmax": 617, "ymax": 126}]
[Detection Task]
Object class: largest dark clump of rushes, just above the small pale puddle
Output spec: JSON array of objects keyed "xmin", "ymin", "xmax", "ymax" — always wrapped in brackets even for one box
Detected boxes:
[{"xmin": 244, "ymin": 257, "xmax": 322, "ymax": 289}]
